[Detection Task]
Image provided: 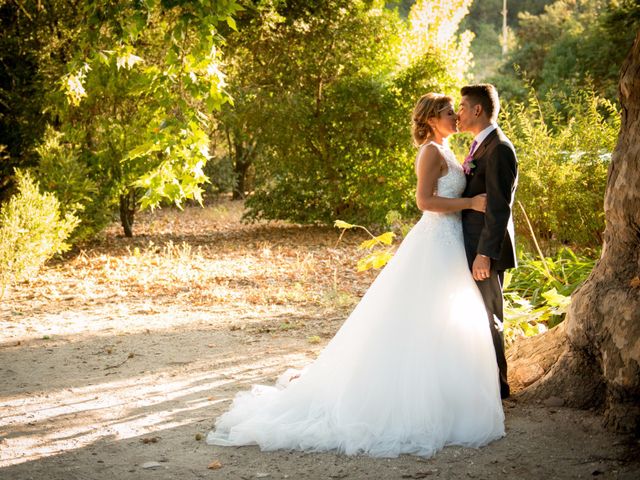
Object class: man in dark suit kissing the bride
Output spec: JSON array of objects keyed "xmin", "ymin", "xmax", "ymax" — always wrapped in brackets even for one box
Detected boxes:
[{"xmin": 458, "ymin": 84, "xmax": 518, "ymax": 398}]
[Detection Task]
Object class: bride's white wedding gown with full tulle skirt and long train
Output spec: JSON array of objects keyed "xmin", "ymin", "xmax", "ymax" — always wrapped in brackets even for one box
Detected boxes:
[{"xmin": 207, "ymin": 144, "xmax": 504, "ymax": 457}]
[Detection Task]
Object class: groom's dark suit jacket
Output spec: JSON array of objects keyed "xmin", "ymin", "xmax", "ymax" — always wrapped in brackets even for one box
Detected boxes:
[{"xmin": 462, "ymin": 128, "xmax": 518, "ymax": 271}]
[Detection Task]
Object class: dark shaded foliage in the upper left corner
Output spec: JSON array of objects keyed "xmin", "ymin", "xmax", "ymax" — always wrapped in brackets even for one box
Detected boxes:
[{"xmin": 0, "ymin": 0, "xmax": 82, "ymax": 199}]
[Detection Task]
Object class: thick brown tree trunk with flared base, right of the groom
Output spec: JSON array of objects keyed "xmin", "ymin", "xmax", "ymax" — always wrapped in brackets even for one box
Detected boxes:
[{"xmin": 511, "ymin": 32, "xmax": 640, "ymax": 435}]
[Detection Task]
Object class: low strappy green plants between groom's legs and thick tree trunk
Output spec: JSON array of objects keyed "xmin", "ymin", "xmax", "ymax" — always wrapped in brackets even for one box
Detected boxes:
[{"xmin": 504, "ymin": 248, "xmax": 595, "ymax": 345}]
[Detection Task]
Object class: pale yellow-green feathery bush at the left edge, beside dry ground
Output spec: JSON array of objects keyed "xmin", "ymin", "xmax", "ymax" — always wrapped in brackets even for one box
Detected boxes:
[{"xmin": 0, "ymin": 171, "xmax": 78, "ymax": 296}]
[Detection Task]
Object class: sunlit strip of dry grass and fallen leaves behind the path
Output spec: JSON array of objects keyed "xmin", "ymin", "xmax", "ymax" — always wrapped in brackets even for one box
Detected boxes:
[{"xmin": 3, "ymin": 201, "xmax": 375, "ymax": 342}]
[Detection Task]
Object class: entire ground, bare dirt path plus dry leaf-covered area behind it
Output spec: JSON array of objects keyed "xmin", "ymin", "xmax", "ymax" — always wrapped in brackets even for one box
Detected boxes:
[{"xmin": 0, "ymin": 201, "xmax": 640, "ymax": 480}]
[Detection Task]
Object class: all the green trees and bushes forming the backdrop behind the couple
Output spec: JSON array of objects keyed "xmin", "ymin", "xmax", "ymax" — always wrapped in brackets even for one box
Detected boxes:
[{"xmin": 0, "ymin": 0, "xmax": 640, "ymax": 338}]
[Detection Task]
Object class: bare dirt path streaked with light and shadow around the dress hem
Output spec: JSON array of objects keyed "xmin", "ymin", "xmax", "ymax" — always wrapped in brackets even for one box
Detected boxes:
[{"xmin": 0, "ymin": 319, "xmax": 640, "ymax": 480}]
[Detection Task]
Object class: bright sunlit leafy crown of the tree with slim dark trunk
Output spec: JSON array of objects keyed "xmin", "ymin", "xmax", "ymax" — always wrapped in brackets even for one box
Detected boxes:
[{"xmin": 45, "ymin": 0, "xmax": 241, "ymax": 236}]
